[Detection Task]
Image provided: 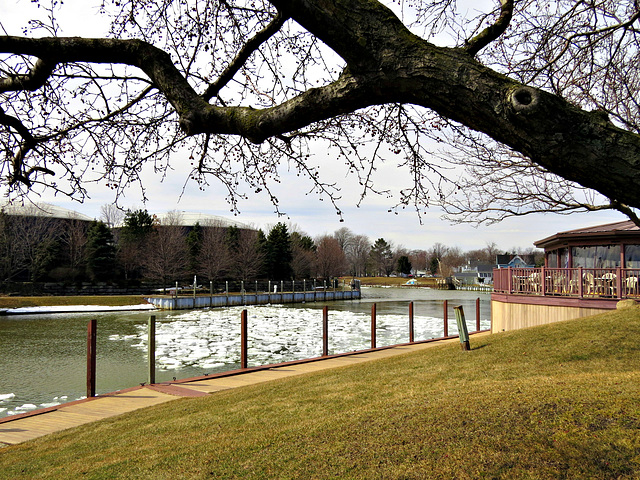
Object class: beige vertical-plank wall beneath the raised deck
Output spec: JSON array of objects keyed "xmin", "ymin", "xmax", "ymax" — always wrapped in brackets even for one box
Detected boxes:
[{"xmin": 491, "ymin": 300, "xmax": 610, "ymax": 333}]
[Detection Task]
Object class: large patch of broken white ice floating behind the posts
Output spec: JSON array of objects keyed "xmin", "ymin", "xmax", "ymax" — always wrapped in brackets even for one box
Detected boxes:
[{"xmin": 110, "ymin": 305, "xmax": 442, "ymax": 370}]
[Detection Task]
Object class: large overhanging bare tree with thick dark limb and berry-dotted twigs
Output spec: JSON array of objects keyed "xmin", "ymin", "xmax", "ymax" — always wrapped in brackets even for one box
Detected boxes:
[{"xmin": 0, "ymin": 0, "xmax": 640, "ymax": 226}]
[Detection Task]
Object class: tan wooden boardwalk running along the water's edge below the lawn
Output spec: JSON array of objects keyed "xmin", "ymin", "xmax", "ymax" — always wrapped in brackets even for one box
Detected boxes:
[{"xmin": 0, "ymin": 332, "xmax": 488, "ymax": 447}]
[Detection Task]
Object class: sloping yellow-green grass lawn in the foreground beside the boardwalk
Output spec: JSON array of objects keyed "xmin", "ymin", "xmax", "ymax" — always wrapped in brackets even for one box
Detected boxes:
[{"xmin": 0, "ymin": 308, "xmax": 640, "ymax": 479}]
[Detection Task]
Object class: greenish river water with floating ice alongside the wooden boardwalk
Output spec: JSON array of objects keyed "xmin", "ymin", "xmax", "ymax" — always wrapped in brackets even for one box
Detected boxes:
[{"xmin": 0, "ymin": 288, "xmax": 491, "ymax": 417}]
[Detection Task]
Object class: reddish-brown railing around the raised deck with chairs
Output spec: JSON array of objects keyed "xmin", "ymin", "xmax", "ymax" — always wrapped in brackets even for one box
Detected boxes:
[{"xmin": 493, "ymin": 267, "xmax": 640, "ymax": 299}]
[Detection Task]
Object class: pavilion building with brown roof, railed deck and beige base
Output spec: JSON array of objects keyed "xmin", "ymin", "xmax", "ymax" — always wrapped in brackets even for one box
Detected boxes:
[{"xmin": 491, "ymin": 221, "xmax": 640, "ymax": 332}]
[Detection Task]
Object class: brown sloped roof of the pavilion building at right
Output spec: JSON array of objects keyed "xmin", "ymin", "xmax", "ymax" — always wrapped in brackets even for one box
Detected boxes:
[{"xmin": 534, "ymin": 220, "xmax": 640, "ymax": 249}]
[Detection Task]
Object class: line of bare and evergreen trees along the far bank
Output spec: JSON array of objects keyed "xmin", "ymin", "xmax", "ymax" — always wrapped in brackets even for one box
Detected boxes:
[{"xmin": 0, "ymin": 205, "xmax": 530, "ymax": 286}]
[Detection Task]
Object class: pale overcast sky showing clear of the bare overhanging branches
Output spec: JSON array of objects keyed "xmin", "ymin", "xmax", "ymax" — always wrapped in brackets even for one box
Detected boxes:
[{"xmin": 0, "ymin": 0, "xmax": 626, "ymax": 250}]
